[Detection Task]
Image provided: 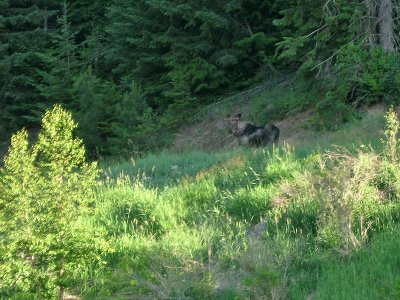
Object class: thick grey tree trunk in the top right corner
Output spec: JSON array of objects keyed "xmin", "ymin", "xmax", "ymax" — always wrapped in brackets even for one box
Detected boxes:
[{"xmin": 379, "ymin": 0, "xmax": 394, "ymax": 52}]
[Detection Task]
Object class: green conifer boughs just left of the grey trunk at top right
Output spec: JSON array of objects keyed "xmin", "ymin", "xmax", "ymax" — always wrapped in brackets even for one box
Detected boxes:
[{"xmin": 273, "ymin": 0, "xmax": 366, "ymax": 73}]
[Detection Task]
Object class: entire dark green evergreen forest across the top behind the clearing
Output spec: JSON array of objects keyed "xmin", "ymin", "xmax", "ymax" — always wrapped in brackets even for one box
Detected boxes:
[{"xmin": 0, "ymin": 0, "xmax": 400, "ymax": 156}]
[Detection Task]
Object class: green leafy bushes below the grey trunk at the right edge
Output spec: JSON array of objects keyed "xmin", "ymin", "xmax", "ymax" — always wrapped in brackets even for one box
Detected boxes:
[{"xmin": 304, "ymin": 42, "xmax": 399, "ymax": 129}]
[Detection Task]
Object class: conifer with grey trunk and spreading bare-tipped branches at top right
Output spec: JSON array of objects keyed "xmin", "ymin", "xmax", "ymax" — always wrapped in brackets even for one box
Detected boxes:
[{"xmin": 274, "ymin": 0, "xmax": 398, "ymax": 74}]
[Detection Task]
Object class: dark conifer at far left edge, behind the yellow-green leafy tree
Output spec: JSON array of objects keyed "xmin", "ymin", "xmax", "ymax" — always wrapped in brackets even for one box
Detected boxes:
[{"xmin": 0, "ymin": 0, "xmax": 59, "ymax": 132}]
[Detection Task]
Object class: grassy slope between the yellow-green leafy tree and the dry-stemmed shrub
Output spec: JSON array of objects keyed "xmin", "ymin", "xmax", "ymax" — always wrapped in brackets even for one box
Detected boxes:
[{"xmin": 85, "ymin": 83, "xmax": 400, "ymax": 299}]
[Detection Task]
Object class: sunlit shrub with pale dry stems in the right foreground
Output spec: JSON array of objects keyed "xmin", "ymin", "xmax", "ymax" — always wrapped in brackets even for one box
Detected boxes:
[{"xmin": 265, "ymin": 109, "xmax": 400, "ymax": 253}]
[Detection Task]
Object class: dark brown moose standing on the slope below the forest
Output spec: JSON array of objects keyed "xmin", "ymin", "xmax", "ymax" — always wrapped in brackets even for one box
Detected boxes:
[{"xmin": 226, "ymin": 113, "xmax": 280, "ymax": 147}]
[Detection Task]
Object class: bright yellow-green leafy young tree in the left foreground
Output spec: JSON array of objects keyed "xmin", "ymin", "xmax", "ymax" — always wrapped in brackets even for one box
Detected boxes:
[{"xmin": 0, "ymin": 106, "xmax": 103, "ymax": 299}]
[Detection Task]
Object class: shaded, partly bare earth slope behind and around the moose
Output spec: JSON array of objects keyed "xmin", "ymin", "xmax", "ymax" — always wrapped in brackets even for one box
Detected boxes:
[{"xmin": 170, "ymin": 79, "xmax": 386, "ymax": 152}]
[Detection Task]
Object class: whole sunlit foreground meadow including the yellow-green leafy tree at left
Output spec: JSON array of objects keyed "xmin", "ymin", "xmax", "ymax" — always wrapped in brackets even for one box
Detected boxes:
[{"xmin": 0, "ymin": 99, "xmax": 400, "ymax": 300}]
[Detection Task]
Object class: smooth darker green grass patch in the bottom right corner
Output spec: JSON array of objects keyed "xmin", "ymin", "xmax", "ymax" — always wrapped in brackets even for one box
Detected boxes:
[{"xmin": 315, "ymin": 228, "xmax": 400, "ymax": 300}]
